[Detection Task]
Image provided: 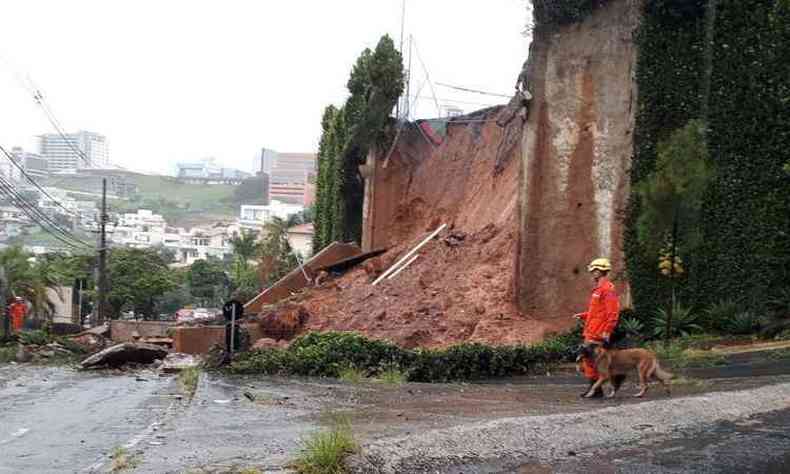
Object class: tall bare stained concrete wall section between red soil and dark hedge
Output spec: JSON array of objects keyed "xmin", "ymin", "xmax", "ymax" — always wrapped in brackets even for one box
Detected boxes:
[{"xmin": 516, "ymin": 0, "xmax": 640, "ymax": 325}]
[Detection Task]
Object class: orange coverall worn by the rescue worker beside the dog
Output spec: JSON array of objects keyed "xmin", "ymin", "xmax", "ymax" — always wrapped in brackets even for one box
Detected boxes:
[{"xmin": 580, "ymin": 277, "xmax": 620, "ymax": 380}]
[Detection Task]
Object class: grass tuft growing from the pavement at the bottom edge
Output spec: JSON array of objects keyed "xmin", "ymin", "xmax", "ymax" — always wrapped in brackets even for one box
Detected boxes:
[{"xmin": 292, "ymin": 417, "xmax": 359, "ymax": 474}]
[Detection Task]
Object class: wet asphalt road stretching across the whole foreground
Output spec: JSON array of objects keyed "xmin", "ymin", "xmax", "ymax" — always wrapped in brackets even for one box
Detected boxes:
[{"xmin": 0, "ymin": 361, "xmax": 790, "ymax": 474}]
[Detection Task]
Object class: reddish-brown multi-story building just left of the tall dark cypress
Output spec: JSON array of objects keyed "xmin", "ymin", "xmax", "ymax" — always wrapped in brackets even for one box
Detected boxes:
[{"xmin": 255, "ymin": 148, "xmax": 317, "ymax": 206}]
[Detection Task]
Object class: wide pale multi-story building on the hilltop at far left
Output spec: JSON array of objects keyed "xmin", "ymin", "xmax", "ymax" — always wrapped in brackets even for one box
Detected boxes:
[{"xmin": 38, "ymin": 130, "xmax": 110, "ymax": 173}]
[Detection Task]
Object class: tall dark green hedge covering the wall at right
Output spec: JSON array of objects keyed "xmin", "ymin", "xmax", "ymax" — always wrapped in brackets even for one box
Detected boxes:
[{"xmin": 624, "ymin": 0, "xmax": 790, "ymax": 318}]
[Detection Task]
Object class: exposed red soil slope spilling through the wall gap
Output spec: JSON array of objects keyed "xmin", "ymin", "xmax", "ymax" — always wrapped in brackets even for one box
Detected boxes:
[{"xmin": 290, "ymin": 110, "xmax": 560, "ymax": 347}]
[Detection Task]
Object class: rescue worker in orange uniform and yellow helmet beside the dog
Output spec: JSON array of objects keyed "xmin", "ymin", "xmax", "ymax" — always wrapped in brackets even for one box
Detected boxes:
[{"xmin": 574, "ymin": 258, "xmax": 622, "ymax": 397}]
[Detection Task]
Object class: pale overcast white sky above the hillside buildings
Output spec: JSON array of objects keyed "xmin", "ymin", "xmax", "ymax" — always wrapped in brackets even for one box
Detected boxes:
[{"xmin": 0, "ymin": 0, "xmax": 528, "ymax": 172}]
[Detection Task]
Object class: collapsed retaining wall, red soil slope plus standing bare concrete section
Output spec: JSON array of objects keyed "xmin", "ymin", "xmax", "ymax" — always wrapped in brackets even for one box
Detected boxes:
[{"xmin": 256, "ymin": 0, "xmax": 640, "ymax": 347}]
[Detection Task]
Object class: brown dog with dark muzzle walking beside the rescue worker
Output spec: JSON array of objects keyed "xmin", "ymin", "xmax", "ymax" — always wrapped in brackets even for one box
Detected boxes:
[{"xmin": 584, "ymin": 346, "xmax": 672, "ymax": 398}]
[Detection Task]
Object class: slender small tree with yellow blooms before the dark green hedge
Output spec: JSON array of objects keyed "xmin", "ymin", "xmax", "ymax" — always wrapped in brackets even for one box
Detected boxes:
[{"xmin": 637, "ymin": 120, "xmax": 713, "ymax": 340}]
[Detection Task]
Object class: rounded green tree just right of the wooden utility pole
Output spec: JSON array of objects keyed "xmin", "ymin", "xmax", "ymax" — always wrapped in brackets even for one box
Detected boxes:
[{"xmin": 107, "ymin": 248, "xmax": 177, "ymax": 320}]
